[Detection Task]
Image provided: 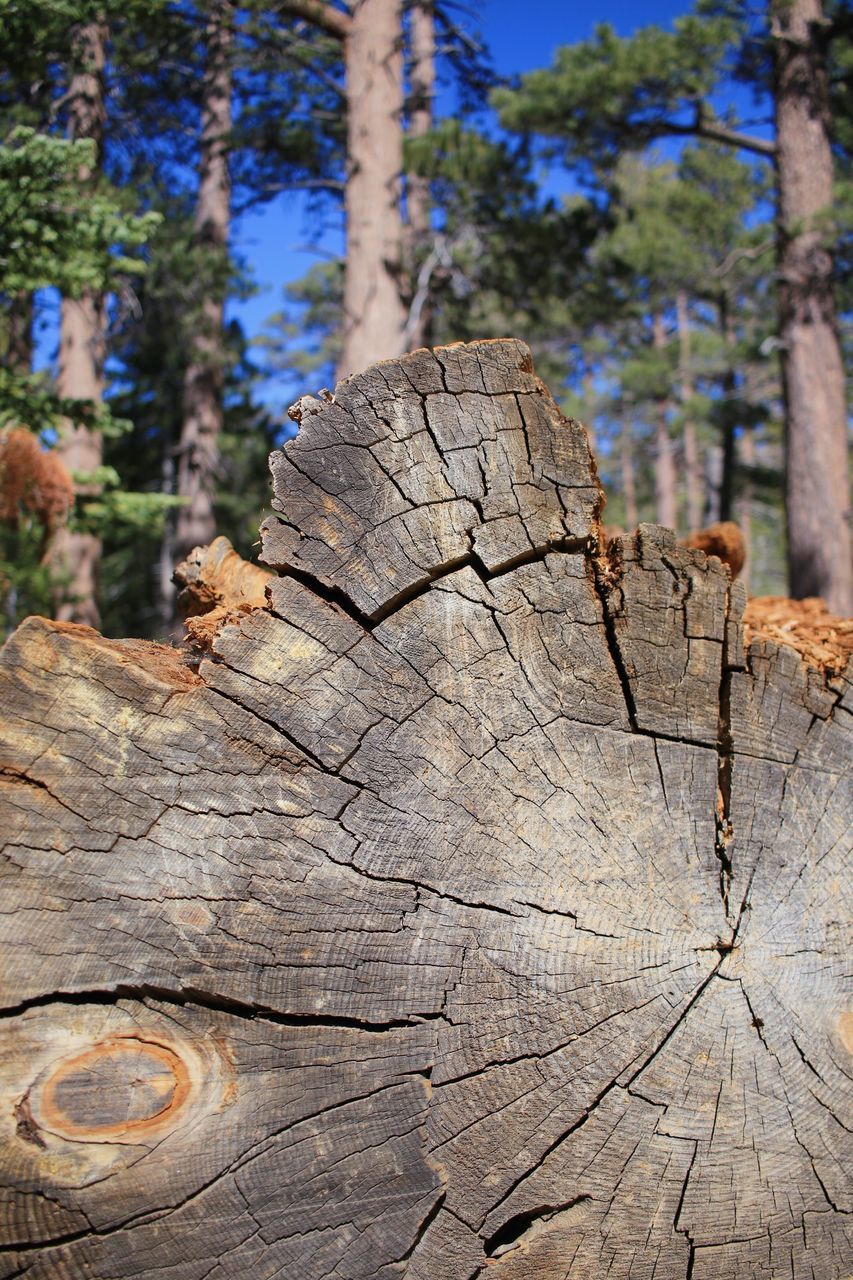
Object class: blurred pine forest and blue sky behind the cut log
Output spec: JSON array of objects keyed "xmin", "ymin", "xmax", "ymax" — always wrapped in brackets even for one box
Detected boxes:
[{"xmin": 0, "ymin": 0, "xmax": 853, "ymax": 637}]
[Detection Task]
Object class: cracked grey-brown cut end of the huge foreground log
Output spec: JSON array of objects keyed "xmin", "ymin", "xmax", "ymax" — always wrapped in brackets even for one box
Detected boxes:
[{"xmin": 0, "ymin": 342, "xmax": 853, "ymax": 1280}]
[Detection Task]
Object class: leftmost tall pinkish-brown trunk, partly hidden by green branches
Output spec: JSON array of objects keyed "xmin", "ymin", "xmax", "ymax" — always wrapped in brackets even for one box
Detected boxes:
[{"xmin": 51, "ymin": 22, "xmax": 106, "ymax": 627}]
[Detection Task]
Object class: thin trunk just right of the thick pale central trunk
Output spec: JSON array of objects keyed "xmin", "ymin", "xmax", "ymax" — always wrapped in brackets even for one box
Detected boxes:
[{"xmin": 406, "ymin": 0, "xmax": 435, "ymax": 348}]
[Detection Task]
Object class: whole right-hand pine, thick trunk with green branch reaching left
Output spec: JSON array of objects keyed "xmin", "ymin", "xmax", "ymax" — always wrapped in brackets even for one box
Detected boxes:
[{"xmin": 496, "ymin": 0, "xmax": 853, "ymax": 612}]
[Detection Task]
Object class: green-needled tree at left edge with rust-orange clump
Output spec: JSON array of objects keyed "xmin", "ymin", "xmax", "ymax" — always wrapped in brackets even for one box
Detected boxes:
[{"xmin": 0, "ymin": 83, "xmax": 158, "ymax": 627}]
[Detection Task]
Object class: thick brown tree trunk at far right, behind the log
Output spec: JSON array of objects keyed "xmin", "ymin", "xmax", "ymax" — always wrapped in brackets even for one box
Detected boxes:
[{"xmin": 771, "ymin": 0, "xmax": 853, "ymax": 614}]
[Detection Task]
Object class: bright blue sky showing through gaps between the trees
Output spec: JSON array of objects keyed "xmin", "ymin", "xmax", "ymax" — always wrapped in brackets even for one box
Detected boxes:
[{"xmin": 231, "ymin": 0, "xmax": 690, "ymax": 413}]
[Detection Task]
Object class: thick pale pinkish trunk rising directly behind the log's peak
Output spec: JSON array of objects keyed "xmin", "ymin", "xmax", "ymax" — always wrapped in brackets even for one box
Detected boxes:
[{"xmin": 338, "ymin": 0, "xmax": 406, "ymax": 376}]
